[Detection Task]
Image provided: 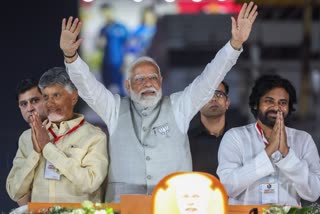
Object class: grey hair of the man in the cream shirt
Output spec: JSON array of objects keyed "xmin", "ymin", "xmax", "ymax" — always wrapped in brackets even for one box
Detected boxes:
[{"xmin": 39, "ymin": 67, "xmax": 77, "ymax": 94}]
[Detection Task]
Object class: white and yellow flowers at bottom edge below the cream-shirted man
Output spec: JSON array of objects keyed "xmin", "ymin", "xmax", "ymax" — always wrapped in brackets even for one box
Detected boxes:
[{"xmin": 41, "ymin": 201, "xmax": 115, "ymax": 214}]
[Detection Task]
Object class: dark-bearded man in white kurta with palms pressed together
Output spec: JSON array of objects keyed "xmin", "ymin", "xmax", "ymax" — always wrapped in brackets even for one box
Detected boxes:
[{"xmin": 217, "ymin": 75, "xmax": 320, "ymax": 206}]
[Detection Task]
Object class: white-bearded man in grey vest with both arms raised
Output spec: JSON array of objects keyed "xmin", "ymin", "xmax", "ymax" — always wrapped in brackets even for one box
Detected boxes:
[{"xmin": 60, "ymin": 2, "xmax": 257, "ymax": 202}]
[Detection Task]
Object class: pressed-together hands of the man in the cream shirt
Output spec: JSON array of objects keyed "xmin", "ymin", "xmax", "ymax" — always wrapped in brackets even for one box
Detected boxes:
[{"xmin": 30, "ymin": 112, "xmax": 50, "ymax": 153}]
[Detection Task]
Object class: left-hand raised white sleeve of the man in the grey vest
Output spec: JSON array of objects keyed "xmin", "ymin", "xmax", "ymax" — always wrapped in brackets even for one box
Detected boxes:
[{"xmin": 65, "ymin": 57, "xmax": 120, "ymax": 135}]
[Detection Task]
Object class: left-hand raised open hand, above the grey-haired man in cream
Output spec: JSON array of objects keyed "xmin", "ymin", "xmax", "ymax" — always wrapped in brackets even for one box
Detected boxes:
[{"xmin": 60, "ymin": 16, "xmax": 83, "ymax": 56}]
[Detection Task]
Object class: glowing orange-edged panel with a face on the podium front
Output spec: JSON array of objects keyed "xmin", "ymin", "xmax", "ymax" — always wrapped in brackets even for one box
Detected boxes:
[{"xmin": 152, "ymin": 172, "xmax": 228, "ymax": 214}]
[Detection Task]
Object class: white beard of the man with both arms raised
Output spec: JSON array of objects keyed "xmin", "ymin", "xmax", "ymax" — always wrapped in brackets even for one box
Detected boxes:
[{"xmin": 130, "ymin": 87, "xmax": 162, "ymax": 108}]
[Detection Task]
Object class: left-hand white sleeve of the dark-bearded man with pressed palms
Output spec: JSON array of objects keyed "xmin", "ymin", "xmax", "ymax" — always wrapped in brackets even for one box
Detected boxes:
[{"xmin": 217, "ymin": 127, "xmax": 274, "ymax": 198}]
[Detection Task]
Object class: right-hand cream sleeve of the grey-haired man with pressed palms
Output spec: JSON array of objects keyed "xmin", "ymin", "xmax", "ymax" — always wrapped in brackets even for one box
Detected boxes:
[{"xmin": 43, "ymin": 127, "xmax": 108, "ymax": 194}]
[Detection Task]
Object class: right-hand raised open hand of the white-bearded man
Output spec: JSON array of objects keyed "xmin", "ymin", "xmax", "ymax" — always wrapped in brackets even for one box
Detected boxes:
[{"xmin": 231, "ymin": 2, "xmax": 258, "ymax": 49}]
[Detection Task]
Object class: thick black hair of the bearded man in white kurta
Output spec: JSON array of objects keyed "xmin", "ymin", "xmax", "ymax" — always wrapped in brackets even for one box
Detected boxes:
[{"xmin": 249, "ymin": 74, "xmax": 297, "ymax": 118}]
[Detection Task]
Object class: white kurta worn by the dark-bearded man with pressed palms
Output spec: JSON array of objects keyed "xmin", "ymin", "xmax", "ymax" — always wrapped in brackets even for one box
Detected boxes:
[{"xmin": 217, "ymin": 123, "xmax": 320, "ymax": 205}]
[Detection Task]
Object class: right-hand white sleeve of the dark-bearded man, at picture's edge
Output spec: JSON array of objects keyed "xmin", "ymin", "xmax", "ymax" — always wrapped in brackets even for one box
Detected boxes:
[{"xmin": 276, "ymin": 129, "xmax": 320, "ymax": 201}]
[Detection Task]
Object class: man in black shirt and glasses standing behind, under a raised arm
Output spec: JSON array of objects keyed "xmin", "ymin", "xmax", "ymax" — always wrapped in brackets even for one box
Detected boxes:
[{"xmin": 188, "ymin": 81, "xmax": 245, "ymax": 177}]
